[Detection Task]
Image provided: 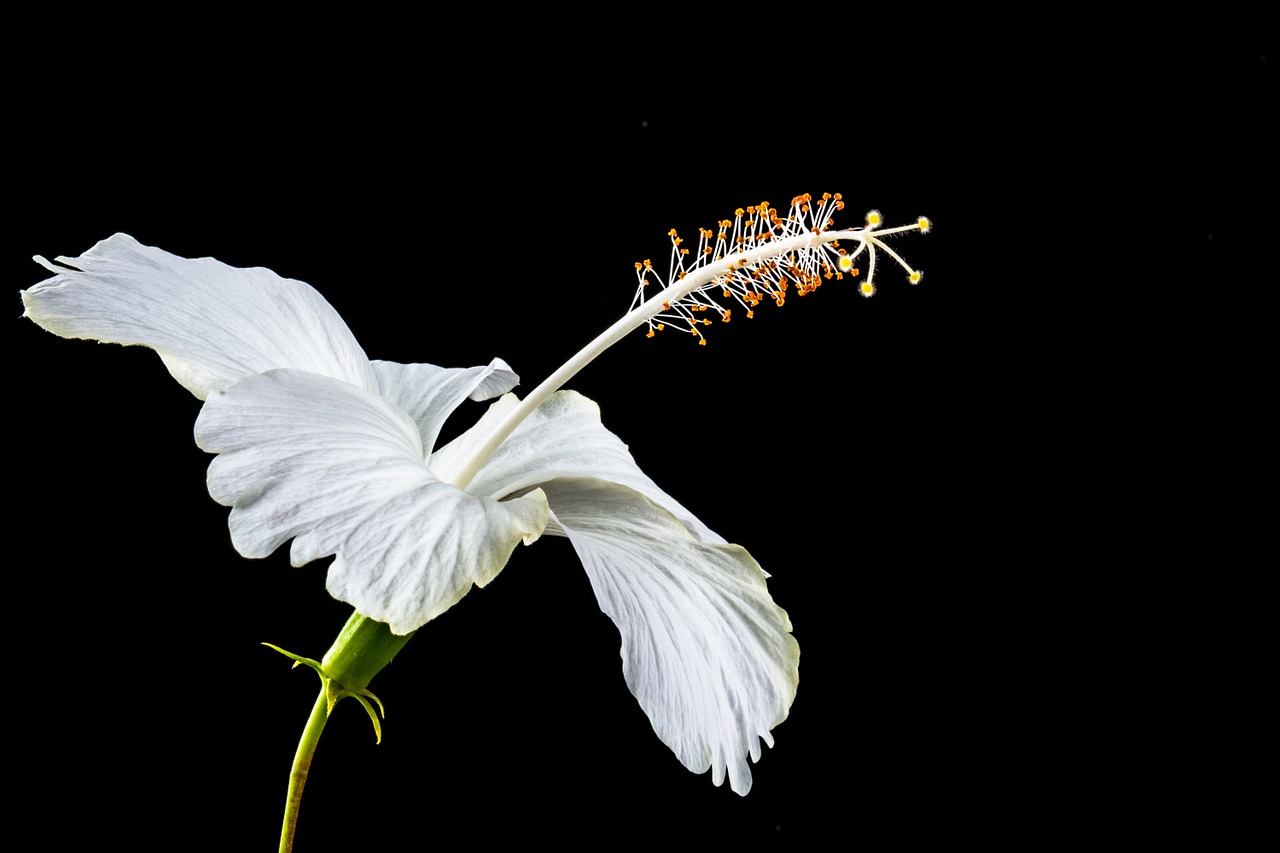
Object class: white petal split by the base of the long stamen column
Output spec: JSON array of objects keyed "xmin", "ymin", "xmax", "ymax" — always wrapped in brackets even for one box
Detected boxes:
[{"xmin": 431, "ymin": 391, "xmax": 724, "ymax": 544}]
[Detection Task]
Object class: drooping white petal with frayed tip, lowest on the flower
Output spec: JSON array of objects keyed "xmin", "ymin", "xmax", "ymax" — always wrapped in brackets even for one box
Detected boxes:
[{"xmin": 543, "ymin": 479, "xmax": 800, "ymax": 795}]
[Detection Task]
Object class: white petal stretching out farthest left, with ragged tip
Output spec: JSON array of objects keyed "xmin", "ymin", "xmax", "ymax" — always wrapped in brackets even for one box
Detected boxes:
[{"xmin": 22, "ymin": 234, "xmax": 376, "ymax": 400}]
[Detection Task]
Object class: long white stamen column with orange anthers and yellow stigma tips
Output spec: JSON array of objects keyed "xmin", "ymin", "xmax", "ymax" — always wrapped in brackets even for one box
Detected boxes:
[{"xmin": 453, "ymin": 195, "xmax": 928, "ymax": 489}]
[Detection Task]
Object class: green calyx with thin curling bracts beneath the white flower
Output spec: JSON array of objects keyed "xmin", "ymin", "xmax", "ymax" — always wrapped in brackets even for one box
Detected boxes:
[{"xmin": 262, "ymin": 613, "xmax": 413, "ymax": 743}]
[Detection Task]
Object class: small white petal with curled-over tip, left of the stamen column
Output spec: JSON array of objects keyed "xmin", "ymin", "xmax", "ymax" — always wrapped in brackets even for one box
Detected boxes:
[{"xmin": 372, "ymin": 359, "xmax": 520, "ymax": 459}]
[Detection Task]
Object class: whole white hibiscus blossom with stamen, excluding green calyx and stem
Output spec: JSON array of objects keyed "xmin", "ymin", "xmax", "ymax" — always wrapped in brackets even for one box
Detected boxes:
[{"xmin": 23, "ymin": 196, "xmax": 928, "ymax": 794}]
